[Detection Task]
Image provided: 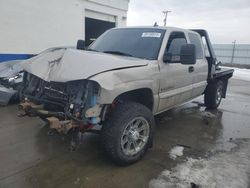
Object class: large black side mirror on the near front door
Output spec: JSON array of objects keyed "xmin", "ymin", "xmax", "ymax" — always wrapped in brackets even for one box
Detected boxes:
[{"xmin": 180, "ymin": 44, "xmax": 196, "ymax": 65}]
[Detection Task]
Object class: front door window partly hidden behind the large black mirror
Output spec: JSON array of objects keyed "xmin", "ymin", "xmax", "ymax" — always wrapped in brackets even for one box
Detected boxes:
[{"xmin": 165, "ymin": 32, "xmax": 187, "ymax": 62}]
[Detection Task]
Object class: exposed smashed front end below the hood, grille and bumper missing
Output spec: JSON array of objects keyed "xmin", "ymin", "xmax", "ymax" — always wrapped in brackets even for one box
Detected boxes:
[{"xmin": 19, "ymin": 72, "xmax": 105, "ymax": 134}]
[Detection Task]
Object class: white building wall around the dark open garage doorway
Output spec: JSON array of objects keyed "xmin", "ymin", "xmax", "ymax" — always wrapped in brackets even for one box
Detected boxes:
[{"xmin": 0, "ymin": 0, "xmax": 128, "ymax": 54}]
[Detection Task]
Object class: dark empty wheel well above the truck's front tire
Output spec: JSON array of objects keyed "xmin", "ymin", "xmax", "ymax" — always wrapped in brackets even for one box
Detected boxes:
[{"xmin": 114, "ymin": 88, "xmax": 154, "ymax": 111}]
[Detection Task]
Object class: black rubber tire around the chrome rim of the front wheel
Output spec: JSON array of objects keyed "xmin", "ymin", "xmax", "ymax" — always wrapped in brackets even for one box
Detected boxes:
[{"xmin": 100, "ymin": 102, "xmax": 155, "ymax": 166}]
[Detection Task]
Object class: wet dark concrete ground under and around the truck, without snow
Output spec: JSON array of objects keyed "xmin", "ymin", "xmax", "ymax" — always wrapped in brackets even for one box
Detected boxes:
[{"xmin": 0, "ymin": 79, "xmax": 250, "ymax": 188}]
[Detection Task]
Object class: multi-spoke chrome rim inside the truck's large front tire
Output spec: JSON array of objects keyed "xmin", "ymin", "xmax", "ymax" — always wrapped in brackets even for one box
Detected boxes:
[{"xmin": 121, "ymin": 117, "xmax": 150, "ymax": 156}]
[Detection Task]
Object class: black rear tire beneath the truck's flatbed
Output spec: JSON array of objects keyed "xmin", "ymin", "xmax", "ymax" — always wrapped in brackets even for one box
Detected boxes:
[{"xmin": 204, "ymin": 81, "xmax": 224, "ymax": 110}]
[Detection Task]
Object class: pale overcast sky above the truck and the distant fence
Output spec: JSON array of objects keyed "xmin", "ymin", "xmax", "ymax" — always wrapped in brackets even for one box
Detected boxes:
[{"xmin": 127, "ymin": 0, "xmax": 250, "ymax": 44}]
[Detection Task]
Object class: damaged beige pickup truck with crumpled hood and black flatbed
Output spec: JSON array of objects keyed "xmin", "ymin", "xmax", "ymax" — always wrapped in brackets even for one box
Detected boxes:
[{"xmin": 20, "ymin": 27, "xmax": 233, "ymax": 165}]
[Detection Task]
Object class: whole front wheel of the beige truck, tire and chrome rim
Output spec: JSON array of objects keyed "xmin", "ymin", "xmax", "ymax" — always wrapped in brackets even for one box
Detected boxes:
[{"xmin": 101, "ymin": 102, "xmax": 154, "ymax": 165}]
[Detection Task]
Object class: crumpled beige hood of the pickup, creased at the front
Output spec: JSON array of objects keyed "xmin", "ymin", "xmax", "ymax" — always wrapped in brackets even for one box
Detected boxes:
[{"xmin": 21, "ymin": 48, "xmax": 148, "ymax": 82}]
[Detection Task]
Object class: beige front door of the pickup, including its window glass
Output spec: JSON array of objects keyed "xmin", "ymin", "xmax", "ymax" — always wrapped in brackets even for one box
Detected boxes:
[{"xmin": 158, "ymin": 31, "xmax": 193, "ymax": 112}]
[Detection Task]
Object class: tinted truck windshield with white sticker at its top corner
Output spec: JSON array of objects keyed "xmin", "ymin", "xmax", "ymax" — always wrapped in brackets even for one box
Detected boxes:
[{"xmin": 89, "ymin": 28, "xmax": 165, "ymax": 60}]
